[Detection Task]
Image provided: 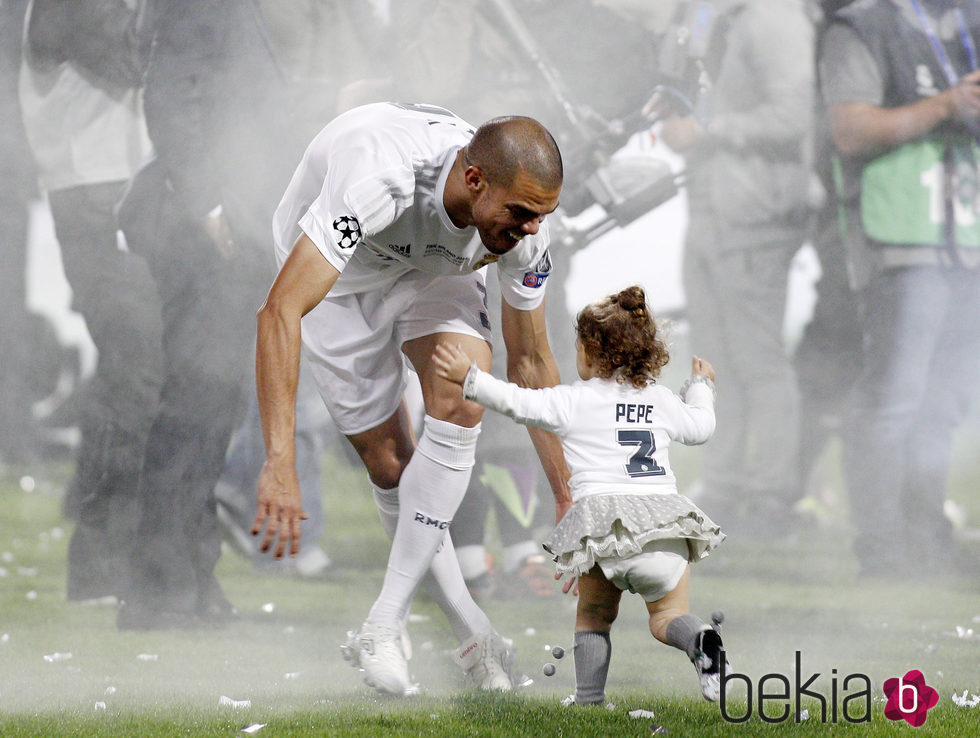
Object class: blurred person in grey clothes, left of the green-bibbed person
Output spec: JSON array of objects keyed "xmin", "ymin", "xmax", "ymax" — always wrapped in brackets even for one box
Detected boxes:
[{"xmin": 660, "ymin": 0, "xmax": 814, "ymax": 540}]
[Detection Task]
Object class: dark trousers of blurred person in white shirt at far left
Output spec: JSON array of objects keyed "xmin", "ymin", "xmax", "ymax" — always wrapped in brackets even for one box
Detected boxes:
[{"xmin": 49, "ymin": 182, "xmax": 163, "ymax": 599}]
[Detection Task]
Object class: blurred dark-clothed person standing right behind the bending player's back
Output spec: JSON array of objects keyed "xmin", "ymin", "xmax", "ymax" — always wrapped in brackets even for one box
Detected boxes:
[{"xmin": 116, "ymin": 0, "xmax": 293, "ymax": 629}]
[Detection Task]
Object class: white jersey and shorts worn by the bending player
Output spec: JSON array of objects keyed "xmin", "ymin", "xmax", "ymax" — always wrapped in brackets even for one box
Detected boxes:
[{"xmin": 273, "ymin": 103, "xmax": 551, "ymax": 435}]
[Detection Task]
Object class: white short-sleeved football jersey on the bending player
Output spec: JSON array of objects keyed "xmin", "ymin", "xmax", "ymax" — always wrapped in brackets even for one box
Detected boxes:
[{"xmin": 273, "ymin": 103, "xmax": 551, "ymax": 310}]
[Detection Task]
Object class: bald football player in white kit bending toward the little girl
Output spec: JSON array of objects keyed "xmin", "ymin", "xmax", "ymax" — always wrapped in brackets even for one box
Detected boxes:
[{"xmin": 252, "ymin": 103, "xmax": 570, "ymax": 696}]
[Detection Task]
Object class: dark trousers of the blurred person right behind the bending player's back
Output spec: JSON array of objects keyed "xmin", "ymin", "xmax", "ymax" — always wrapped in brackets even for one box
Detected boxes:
[{"xmin": 120, "ymin": 163, "xmax": 272, "ymax": 612}]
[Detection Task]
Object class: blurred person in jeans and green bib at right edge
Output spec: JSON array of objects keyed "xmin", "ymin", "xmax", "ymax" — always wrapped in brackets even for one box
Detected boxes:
[{"xmin": 820, "ymin": 0, "xmax": 980, "ymax": 579}]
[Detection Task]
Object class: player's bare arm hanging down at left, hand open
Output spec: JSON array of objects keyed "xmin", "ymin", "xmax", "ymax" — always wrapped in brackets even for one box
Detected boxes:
[{"xmin": 252, "ymin": 233, "xmax": 340, "ymax": 558}]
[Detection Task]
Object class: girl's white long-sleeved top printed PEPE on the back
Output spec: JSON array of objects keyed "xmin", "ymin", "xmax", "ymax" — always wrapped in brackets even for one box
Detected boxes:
[{"xmin": 464, "ymin": 367, "xmax": 715, "ymax": 502}]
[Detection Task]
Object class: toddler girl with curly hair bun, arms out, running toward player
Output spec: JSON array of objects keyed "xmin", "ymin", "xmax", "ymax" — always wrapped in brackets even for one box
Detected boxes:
[{"xmin": 433, "ymin": 286, "xmax": 725, "ymax": 704}]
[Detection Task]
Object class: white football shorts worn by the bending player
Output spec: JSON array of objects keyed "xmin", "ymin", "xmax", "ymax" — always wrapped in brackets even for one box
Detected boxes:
[{"xmin": 302, "ymin": 271, "xmax": 491, "ymax": 435}]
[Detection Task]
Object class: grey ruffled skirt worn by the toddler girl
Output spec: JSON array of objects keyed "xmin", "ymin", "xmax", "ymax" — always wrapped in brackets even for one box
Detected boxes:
[{"xmin": 543, "ymin": 492, "xmax": 725, "ymax": 576}]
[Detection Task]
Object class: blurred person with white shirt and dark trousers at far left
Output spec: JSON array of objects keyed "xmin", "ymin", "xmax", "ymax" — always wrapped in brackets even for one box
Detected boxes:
[{"xmin": 20, "ymin": 0, "xmax": 163, "ymax": 600}]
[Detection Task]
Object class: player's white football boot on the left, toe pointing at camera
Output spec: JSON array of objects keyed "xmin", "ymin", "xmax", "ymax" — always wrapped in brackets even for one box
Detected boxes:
[{"xmin": 340, "ymin": 622, "xmax": 419, "ymax": 697}]
